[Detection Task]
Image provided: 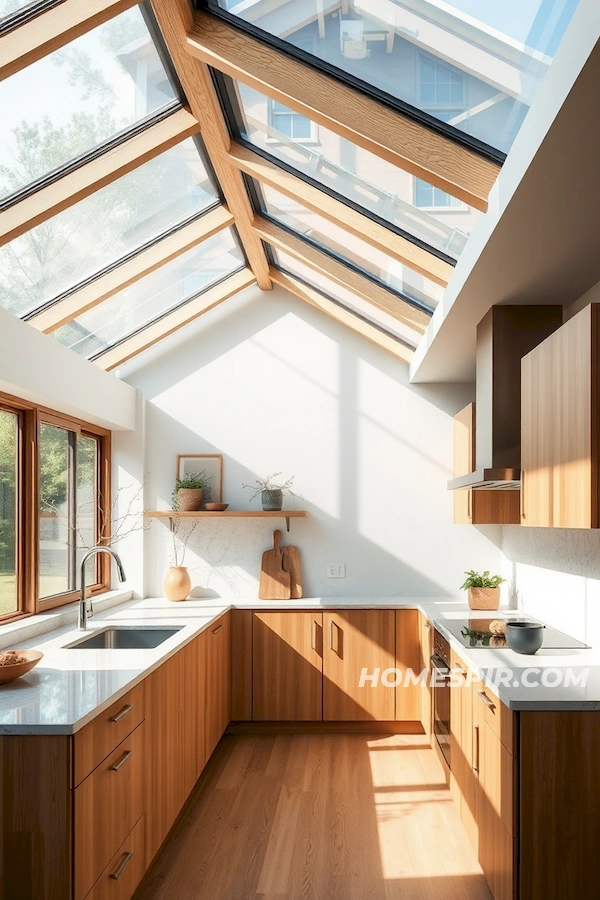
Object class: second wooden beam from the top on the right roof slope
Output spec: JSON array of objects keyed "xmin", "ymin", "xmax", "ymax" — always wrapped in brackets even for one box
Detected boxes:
[{"xmin": 229, "ymin": 143, "xmax": 454, "ymax": 287}]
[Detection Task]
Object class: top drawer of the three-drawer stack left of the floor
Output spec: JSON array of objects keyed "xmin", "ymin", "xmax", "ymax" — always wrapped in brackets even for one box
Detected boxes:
[{"xmin": 73, "ymin": 681, "xmax": 144, "ymax": 787}]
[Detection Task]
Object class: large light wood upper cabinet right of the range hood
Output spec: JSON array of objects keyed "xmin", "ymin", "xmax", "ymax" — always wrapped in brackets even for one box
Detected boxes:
[{"xmin": 521, "ymin": 303, "xmax": 600, "ymax": 528}]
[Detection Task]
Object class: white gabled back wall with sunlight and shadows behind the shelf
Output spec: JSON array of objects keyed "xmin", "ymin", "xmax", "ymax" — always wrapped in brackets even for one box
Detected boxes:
[{"xmin": 122, "ymin": 288, "xmax": 501, "ymax": 596}]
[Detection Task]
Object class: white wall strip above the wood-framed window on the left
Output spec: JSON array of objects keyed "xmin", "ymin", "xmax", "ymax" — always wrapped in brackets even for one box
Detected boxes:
[{"xmin": 0, "ymin": 309, "xmax": 136, "ymax": 430}]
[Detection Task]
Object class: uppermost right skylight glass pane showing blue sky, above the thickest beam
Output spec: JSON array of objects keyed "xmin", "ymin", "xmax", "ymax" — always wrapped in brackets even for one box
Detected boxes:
[{"xmin": 210, "ymin": 0, "xmax": 578, "ymax": 152}]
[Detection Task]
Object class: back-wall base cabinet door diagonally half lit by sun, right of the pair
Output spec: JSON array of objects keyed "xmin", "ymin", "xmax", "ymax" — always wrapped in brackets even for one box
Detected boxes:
[{"xmin": 323, "ymin": 609, "xmax": 396, "ymax": 722}]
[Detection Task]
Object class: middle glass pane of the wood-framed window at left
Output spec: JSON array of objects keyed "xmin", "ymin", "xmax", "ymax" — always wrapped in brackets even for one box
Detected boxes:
[{"xmin": 39, "ymin": 422, "xmax": 73, "ymax": 599}]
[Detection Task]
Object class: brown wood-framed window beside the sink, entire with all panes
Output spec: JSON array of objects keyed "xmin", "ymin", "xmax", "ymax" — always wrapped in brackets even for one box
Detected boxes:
[{"xmin": 0, "ymin": 396, "xmax": 110, "ymax": 620}]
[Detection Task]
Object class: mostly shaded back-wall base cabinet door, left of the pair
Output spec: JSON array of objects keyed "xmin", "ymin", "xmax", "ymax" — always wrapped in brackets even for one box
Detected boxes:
[{"xmin": 252, "ymin": 612, "xmax": 323, "ymax": 722}]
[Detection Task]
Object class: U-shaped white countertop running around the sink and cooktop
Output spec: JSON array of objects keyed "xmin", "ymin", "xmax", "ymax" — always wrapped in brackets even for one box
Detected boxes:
[{"xmin": 0, "ymin": 595, "xmax": 600, "ymax": 734}]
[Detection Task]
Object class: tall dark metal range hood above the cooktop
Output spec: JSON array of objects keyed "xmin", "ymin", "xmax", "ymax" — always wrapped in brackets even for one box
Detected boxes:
[{"xmin": 448, "ymin": 306, "xmax": 563, "ymax": 491}]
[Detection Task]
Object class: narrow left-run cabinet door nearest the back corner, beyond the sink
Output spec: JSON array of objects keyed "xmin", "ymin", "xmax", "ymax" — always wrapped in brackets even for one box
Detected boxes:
[{"xmin": 205, "ymin": 613, "xmax": 231, "ymax": 759}]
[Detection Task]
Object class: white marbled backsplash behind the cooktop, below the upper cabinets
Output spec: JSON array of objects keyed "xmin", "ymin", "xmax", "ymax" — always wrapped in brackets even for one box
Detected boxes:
[{"xmin": 502, "ymin": 525, "xmax": 600, "ymax": 647}]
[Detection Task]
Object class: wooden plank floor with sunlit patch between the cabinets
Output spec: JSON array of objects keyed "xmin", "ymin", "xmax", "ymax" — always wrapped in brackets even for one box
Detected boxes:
[{"xmin": 136, "ymin": 734, "xmax": 491, "ymax": 900}]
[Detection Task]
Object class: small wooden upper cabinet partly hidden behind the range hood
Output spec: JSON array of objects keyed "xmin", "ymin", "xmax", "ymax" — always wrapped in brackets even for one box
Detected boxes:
[{"xmin": 453, "ymin": 403, "xmax": 520, "ymax": 525}]
